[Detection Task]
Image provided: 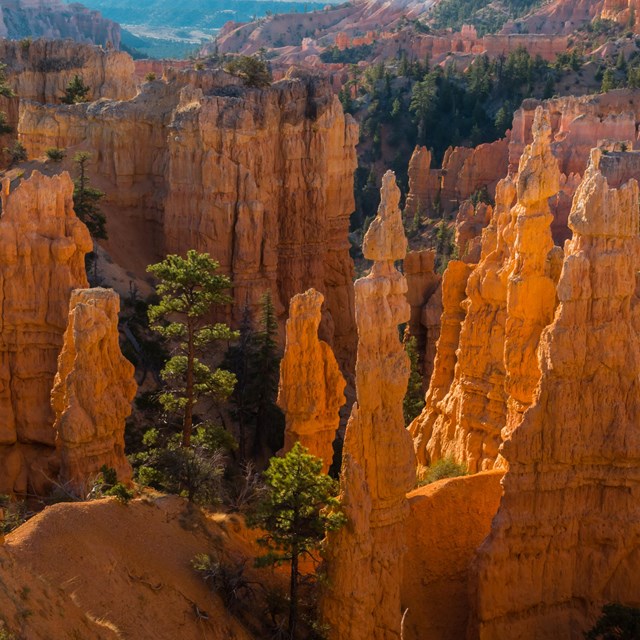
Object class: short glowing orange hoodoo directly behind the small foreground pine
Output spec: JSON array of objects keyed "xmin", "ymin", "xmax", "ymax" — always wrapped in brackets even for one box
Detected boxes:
[{"xmin": 277, "ymin": 289, "xmax": 346, "ymax": 473}]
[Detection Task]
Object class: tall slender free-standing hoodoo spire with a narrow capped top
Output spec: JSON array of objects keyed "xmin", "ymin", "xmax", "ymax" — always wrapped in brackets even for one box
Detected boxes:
[{"xmin": 322, "ymin": 172, "xmax": 414, "ymax": 640}]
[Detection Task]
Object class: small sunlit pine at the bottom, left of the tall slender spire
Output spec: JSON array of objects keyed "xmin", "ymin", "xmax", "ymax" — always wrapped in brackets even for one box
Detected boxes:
[{"xmin": 249, "ymin": 442, "xmax": 346, "ymax": 640}]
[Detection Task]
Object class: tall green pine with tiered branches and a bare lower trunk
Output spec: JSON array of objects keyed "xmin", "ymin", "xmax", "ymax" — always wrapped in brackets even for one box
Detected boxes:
[{"xmin": 147, "ymin": 249, "xmax": 237, "ymax": 447}]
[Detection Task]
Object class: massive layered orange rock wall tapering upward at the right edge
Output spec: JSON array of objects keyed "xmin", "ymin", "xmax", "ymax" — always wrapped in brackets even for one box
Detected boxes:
[{"xmin": 469, "ymin": 151, "xmax": 640, "ymax": 640}]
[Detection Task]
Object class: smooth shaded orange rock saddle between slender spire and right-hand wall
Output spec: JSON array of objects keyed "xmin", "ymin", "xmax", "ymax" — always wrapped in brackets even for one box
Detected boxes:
[{"xmin": 402, "ymin": 471, "xmax": 503, "ymax": 640}]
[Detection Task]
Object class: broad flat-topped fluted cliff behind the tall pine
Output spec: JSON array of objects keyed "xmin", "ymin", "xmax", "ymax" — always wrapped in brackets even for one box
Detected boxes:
[{"xmin": 20, "ymin": 70, "xmax": 357, "ymax": 371}]
